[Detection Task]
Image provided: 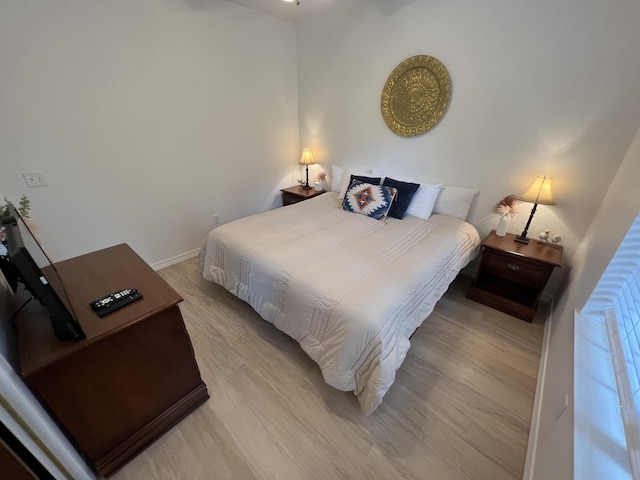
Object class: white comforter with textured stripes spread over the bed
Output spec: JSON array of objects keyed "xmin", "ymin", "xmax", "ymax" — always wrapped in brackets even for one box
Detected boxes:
[{"xmin": 200, "ymin": 194, "xmax": 480, "ymax": 415}]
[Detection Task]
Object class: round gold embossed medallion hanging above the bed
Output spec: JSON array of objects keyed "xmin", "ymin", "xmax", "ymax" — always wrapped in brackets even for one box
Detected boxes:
[{"xmin": 380, "ymin": 55, "xmax": 451, "ymax": 137}]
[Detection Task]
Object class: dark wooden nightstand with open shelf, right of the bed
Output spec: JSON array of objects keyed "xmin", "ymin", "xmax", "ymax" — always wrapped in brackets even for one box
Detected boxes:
[{"xmin": 467, "ymin": 230, "xmax": 562, "ymax": 322}]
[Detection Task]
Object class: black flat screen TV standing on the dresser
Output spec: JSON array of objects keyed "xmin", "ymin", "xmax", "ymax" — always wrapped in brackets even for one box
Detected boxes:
[{"xmin": 0, "ymin": 203, "xmax": 85, "ymax": 341}]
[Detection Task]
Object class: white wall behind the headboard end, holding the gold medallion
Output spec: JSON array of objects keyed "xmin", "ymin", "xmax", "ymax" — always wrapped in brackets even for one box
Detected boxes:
[{"xmin": 298, "ymin": 0, "xmax": 640, "ymax": 293}]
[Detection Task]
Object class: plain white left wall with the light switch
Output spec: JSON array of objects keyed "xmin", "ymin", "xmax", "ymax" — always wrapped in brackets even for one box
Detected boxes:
[{"xmin": 0, "ymin": 0, "xmax": 300, "ymax": 263}]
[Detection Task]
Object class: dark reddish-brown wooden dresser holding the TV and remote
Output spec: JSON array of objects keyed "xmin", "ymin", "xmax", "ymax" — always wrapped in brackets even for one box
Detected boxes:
[{"xmin": 16, "ymin": 244, "xmax": 209, "ymax": 476}]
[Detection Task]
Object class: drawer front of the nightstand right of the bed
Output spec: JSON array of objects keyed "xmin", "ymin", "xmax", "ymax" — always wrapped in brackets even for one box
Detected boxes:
[{"xmin": 481, "ymin": 250, "xmax": 553, "ymax": 287}]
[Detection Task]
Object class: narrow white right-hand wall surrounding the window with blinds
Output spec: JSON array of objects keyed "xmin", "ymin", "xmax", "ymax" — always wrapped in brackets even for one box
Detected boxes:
[{"xmin": 532, "ymin": 124, "xmax": 640, "ymax": 479}]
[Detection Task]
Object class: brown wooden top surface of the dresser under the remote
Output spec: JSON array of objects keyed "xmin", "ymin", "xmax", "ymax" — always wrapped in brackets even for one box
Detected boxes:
[{"xmin": 16, "ymin": 243, "xmax": 182, "ymax": 375}]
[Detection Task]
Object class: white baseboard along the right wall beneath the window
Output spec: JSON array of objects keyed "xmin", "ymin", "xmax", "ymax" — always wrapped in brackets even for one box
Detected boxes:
[{"xmin": 522, "ymin": 294, "xmax": 553, "ymax": 480}]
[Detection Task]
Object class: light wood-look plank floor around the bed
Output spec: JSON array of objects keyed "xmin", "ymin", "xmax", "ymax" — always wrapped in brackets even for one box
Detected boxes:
[{"xmin": 112, "ymin": 258, "xmax": 544, "ymax": 480}]
